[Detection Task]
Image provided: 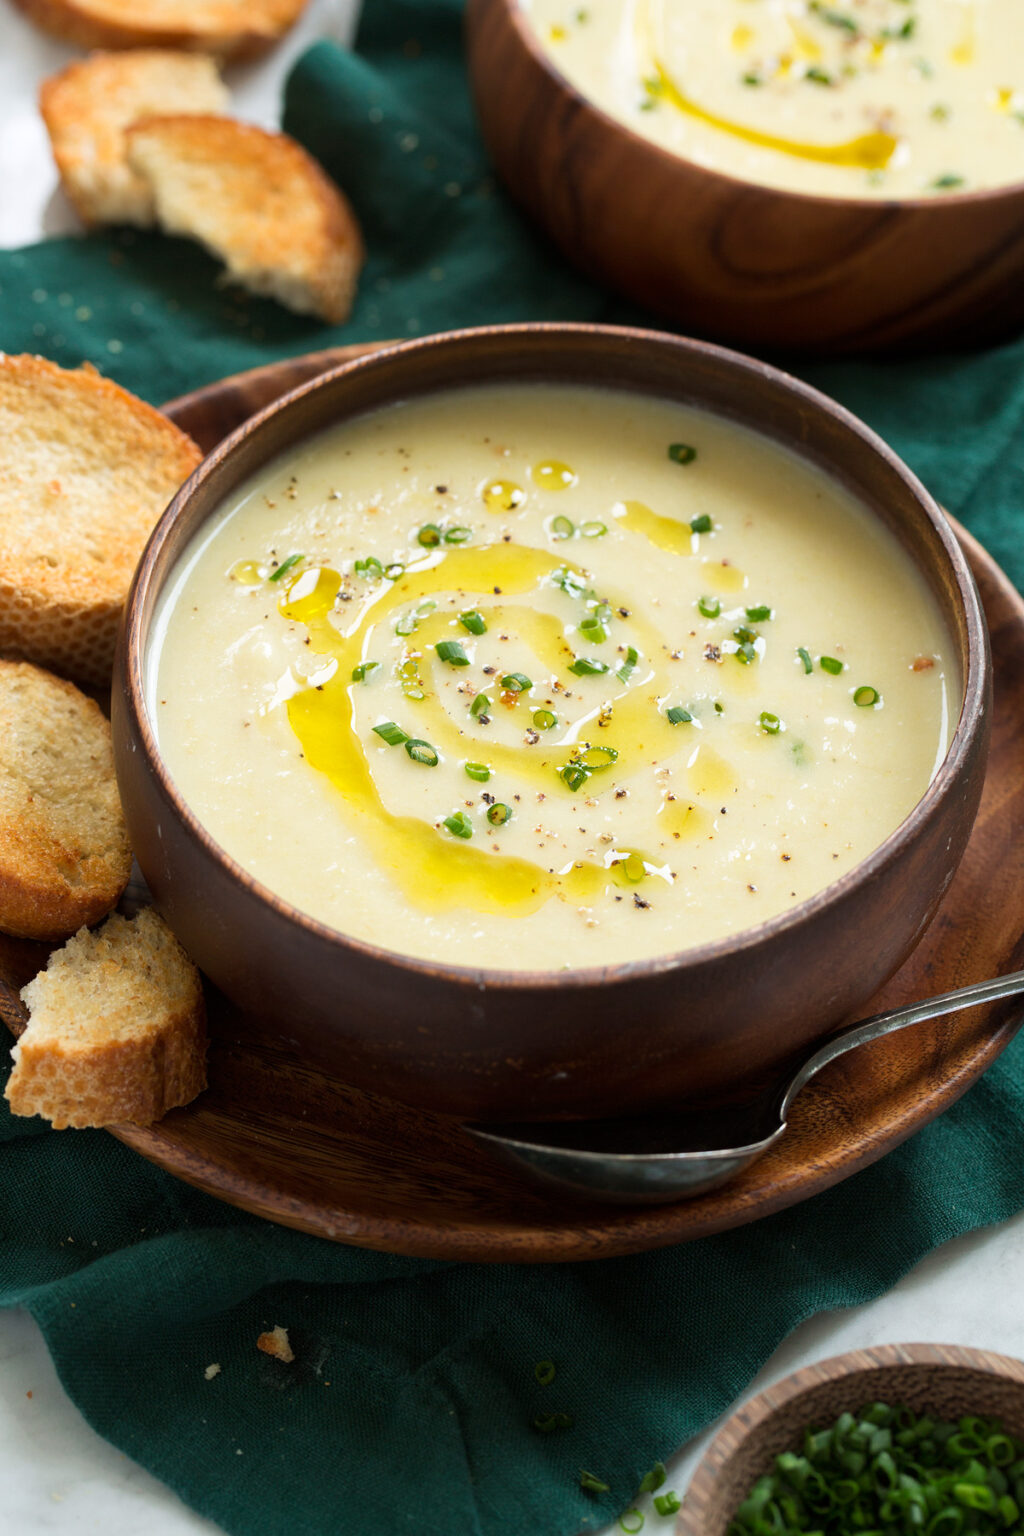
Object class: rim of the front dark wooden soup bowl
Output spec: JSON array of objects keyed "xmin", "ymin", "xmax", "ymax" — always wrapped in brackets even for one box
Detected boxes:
[{"xmin": 115, "ymin": 321, "xmax": 992, "ymax": 994}]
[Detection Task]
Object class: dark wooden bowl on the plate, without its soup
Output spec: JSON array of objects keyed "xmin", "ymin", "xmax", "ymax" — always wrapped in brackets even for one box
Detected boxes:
[{"xmin": 112, "ymin": 326, "xmax": 990, "ymax": 1120}]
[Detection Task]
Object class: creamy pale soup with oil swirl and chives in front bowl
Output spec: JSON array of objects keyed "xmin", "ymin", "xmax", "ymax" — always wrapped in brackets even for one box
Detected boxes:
[{"xmin": 147, "ymin": 386, "xmax": 960, "ymax": 971}]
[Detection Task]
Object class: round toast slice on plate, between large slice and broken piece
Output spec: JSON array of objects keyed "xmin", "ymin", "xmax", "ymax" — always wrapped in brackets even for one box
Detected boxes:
[{"xmin": 0, "ymin": 660, "xmax": 132, "ymax": 940}]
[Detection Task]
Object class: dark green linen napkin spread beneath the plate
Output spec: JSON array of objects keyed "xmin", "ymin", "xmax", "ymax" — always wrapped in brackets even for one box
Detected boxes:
[{"xmin": 0, "ymin": 0, "xmax": 1024, "ymax": 1536}]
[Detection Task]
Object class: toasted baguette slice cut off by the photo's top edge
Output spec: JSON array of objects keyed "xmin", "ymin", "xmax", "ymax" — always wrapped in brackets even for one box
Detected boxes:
[{"xmin": 15, "ymin": 0, "xmax": 306, "ymax": 57}]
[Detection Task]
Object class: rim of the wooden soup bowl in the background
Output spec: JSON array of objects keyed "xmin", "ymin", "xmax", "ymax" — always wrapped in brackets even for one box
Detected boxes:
[{"xmin": 485, "ymin": 0, "xmax": 1024, "ymax": 212}]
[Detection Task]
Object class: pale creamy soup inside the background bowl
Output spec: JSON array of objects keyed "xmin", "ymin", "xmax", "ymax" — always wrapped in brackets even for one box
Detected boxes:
[{"xmin": 522, "ymin": 0, "xmax": 1024, "ymax": 198}]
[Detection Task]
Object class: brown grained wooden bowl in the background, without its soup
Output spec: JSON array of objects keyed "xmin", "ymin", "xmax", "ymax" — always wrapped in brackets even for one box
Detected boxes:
[{"xmin": 467, "ymin": 0, "xmax": 1024, "ymax": 353}]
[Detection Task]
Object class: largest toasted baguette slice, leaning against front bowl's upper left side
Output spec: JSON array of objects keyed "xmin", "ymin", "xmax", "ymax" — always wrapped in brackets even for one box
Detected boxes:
[{"xmin": 0, "ymin": 353, "xmax": 201, "ymax": 687}]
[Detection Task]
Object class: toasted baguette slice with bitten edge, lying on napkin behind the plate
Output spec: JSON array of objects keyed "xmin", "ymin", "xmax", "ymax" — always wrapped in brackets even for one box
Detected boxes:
[{"xmin": 126, "ymin": 117, "xmax": 362, "ymax": 323}]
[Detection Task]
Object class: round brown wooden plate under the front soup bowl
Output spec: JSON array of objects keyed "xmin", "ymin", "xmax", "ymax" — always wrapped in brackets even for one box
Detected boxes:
[{"xmin": 0, "ymin": 349, "xmax": 1024, "ymax": 1263}]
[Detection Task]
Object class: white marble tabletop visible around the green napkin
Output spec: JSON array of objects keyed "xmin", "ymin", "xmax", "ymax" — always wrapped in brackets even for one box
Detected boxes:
[{"xmin": 0, "ymin": 0, "xmax": 1024, "ymax": 1536}]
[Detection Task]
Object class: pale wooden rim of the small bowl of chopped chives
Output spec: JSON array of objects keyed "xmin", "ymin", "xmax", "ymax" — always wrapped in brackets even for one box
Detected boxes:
[{"xmin": 676, "ymin": 1344, "xmax": 1024, "ymax": 1536}]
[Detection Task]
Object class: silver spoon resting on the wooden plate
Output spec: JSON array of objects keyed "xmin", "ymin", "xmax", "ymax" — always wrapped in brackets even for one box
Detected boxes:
[{"xmin": 465, "ymin": 971, "xmax": 1024, "ymax": 1204}]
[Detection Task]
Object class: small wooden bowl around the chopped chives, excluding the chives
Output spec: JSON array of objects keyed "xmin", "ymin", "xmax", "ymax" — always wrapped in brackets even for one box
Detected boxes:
[{"xmin": 676, "ymin": 1344, "xmax": 1024, "ymax": 1536}]
